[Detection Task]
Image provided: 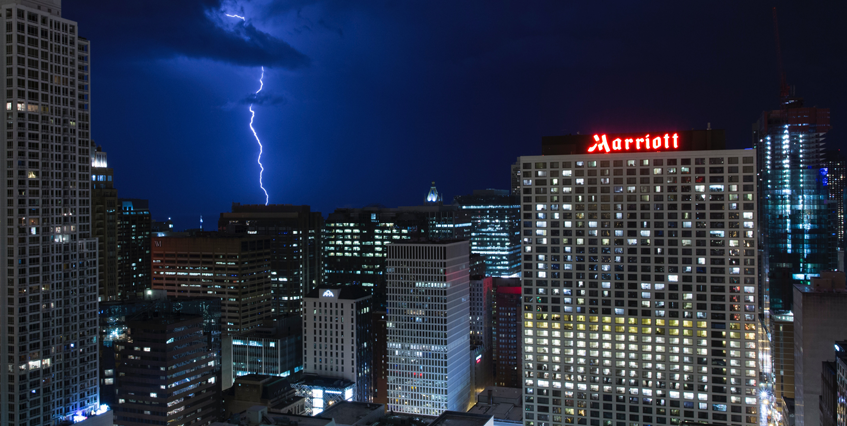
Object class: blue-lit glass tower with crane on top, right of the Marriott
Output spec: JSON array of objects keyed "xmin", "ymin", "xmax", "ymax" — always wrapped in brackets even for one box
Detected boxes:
[{"xmin": 756, "ymin": 97, "xmax": 843, "ymax": 312}]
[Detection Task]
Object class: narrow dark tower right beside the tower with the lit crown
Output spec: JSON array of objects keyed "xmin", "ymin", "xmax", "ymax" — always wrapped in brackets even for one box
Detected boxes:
[{"xmin": 118, "ymin": 198, "xmax": 152, "ymax": 300}]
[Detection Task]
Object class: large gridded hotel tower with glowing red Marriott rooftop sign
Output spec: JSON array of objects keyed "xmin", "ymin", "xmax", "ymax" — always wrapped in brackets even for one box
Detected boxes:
[{"xmin": 513, "ymin": 130, "xmax": 761, "ymax": 426}]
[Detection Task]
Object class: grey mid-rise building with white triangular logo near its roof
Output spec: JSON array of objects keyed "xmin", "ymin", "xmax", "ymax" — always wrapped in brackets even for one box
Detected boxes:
[{"xmin": 300, "ymin": 286, "xmax": 374, "ymax": 415}]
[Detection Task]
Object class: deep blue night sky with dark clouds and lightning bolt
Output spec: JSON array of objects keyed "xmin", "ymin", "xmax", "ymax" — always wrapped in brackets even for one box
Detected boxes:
[{"xmin": 62, "ymin": 0, "xmax": 847, "ymax": 229}]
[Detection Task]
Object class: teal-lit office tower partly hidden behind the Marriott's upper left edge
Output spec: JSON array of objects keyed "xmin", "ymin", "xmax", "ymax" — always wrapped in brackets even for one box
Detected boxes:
[{"xmin": 454, "ymin": 189, "xmax": 521, "ymax": 277}]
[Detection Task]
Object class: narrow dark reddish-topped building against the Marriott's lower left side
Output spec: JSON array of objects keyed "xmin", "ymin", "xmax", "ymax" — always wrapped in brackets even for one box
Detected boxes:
[{"xmin": 493, "ymin": 279, "xmax": 523, "ymax": 388}]
